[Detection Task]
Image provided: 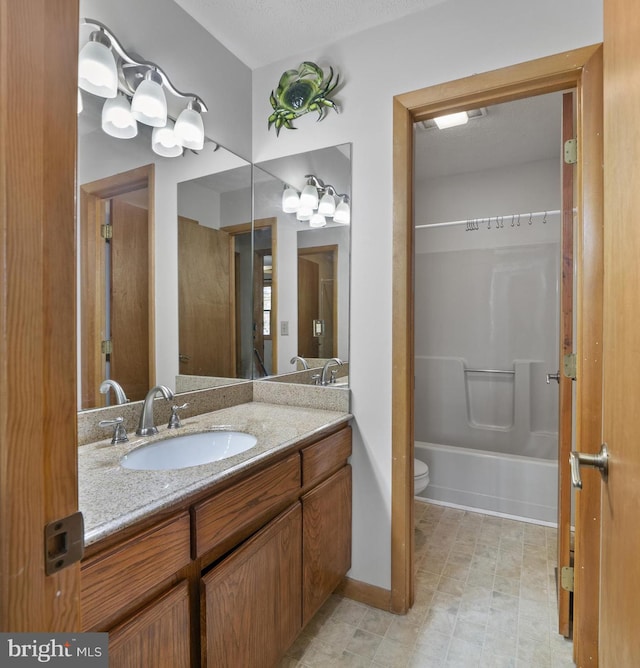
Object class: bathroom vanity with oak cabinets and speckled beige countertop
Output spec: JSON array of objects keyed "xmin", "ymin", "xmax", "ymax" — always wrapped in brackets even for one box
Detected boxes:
[{"xmin": 80, "ymin": 403, "xmax": 351, "ymax": 668}]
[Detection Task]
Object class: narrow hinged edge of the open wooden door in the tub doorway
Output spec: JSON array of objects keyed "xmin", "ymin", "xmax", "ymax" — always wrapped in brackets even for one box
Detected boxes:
[{"xmin": 557, "ymin": 92, "xmax": 576, "ymax": 637}]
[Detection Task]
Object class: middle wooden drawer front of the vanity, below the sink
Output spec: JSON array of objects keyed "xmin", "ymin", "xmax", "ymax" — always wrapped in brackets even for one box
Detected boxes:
[{"xmin": 193, "ymin": 453, "xmax": 300, "ymax": 558}]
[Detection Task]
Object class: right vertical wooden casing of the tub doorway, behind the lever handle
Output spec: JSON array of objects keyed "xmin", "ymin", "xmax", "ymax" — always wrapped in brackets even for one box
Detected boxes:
[{"xmin": 573, "ymin": 48, "xmax": 604, "ymax": 668}]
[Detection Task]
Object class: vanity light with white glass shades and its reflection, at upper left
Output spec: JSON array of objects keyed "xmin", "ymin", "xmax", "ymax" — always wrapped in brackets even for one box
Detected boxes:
[{"xmin": 78, "ymin": 18, "xmax": 208, "ymax": 157}]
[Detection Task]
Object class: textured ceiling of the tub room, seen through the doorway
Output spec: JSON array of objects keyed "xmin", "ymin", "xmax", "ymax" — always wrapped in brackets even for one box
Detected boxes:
[{"xmin": 415, "ymin": 93, "xmax": 562, "ymax": 182}]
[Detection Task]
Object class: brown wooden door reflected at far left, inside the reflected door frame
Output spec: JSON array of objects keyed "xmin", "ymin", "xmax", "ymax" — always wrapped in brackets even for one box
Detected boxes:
[{"xmin": 109, "ymin": 198, "xmax": 152, "ymax": 401}]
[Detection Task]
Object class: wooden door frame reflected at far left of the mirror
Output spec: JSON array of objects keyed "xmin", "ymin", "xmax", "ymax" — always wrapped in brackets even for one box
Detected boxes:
[{"xmin": 80, "ymin": 164, "xmax": 156, "ymax": 408}]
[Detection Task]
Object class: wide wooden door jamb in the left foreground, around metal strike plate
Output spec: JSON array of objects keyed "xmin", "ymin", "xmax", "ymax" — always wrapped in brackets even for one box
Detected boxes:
[{"xmin": 0, "ymin": 0, "xmax": 80, "ymax": 632}]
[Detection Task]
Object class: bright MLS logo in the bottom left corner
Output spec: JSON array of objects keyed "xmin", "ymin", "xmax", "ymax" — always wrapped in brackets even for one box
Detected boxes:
[{"xmin": 0, "ymin": 633, "xmax": 109, "ymax": 668}]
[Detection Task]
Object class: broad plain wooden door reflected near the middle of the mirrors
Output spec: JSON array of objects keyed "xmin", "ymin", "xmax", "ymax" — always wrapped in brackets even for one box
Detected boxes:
[{"xmin": 178, "ymin": 216, "xmax": 235, "ymax": 378}]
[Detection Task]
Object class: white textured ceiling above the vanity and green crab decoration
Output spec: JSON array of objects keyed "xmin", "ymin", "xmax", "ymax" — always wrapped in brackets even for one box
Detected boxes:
[{"xmin": 174, "ymin": 0, "xmax": 446, "ymax": 69}]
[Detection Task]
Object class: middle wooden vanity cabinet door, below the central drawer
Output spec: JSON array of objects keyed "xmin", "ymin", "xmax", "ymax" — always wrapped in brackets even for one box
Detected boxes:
[{"xmin": 201, "ymin": 503, "xmax": 302, "ymax": 668}]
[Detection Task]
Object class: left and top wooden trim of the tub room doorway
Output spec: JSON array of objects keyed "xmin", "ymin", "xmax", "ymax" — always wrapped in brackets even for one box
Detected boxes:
[{"xmin": 391, "ymin": 44, "xmax": 601, "ymax": 613}]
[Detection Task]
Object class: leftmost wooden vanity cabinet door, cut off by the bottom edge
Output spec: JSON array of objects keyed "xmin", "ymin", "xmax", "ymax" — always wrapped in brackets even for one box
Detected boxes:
[{"xmin": 109, "ymin": 581, "xmax": 191, "ymax": 668}]
